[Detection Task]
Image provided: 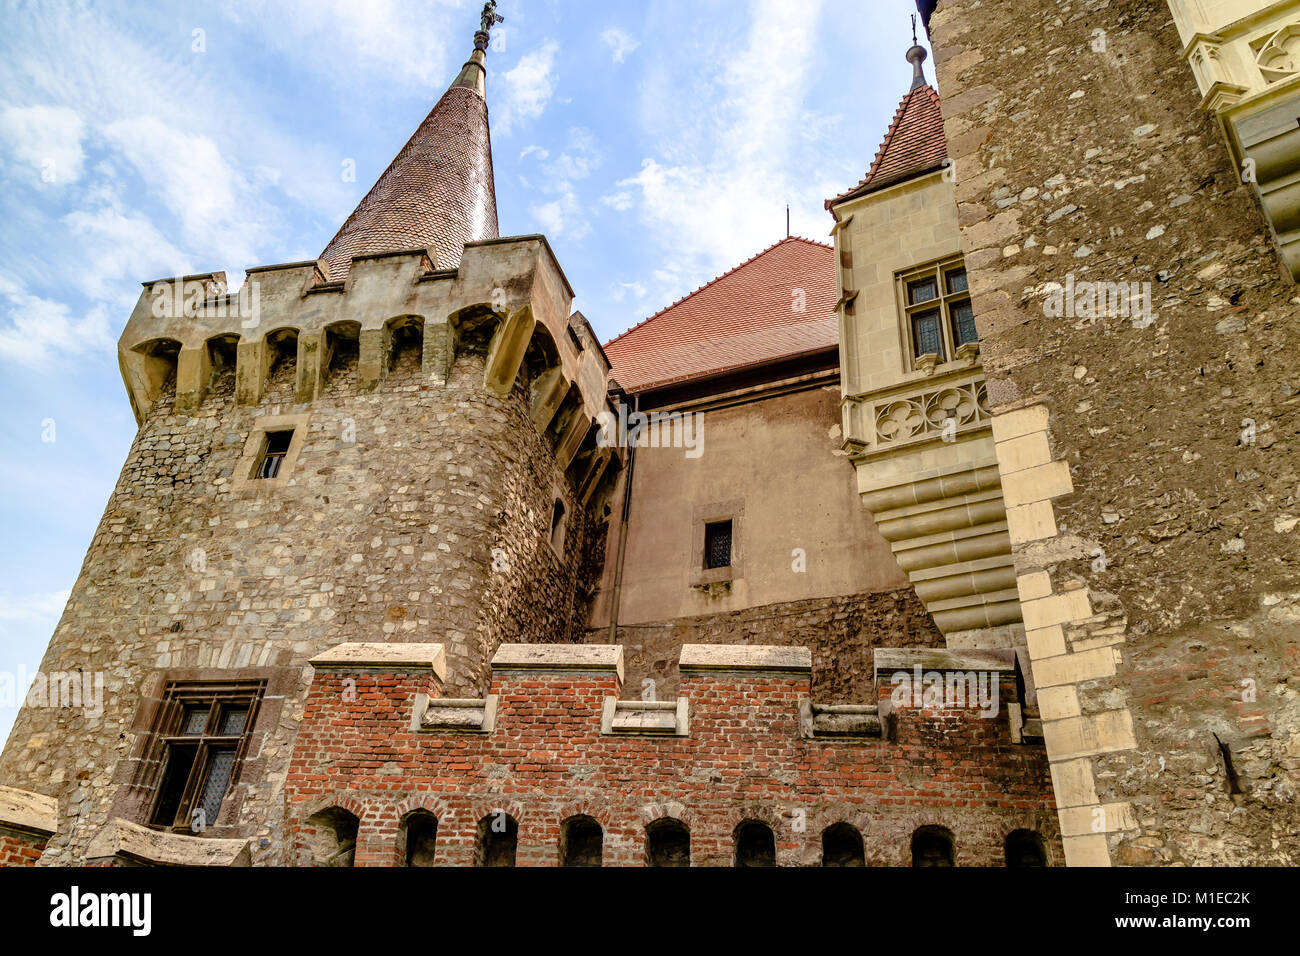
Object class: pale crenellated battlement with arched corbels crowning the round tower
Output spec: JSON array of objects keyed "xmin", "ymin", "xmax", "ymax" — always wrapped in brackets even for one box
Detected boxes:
[{"xmin": 118, "ymin": 235, "xmax": 608, "ymax": 458}]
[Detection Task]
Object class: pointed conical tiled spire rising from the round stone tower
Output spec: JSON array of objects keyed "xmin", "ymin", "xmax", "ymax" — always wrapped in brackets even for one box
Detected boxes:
[{"xmin": 321, "ymin": 12, "xmax": 499, "ymax": 280}]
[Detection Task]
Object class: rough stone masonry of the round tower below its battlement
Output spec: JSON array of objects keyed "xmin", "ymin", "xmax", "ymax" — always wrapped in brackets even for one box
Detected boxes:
[{"xmin": 0, "ymin": 342, "xmax": 589, "ymax": 864}]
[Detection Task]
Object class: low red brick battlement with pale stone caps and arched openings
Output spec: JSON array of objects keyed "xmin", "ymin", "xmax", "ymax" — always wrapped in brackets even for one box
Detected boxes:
[{"xmin": 285, "ymin": 644, "xmax": 1060, "ymax": 865}]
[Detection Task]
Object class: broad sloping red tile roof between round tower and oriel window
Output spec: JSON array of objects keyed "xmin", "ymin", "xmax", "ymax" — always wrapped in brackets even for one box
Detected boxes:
[{"xmin": 605, "ymin": 237, "xmax": 840, "ymax": 392}]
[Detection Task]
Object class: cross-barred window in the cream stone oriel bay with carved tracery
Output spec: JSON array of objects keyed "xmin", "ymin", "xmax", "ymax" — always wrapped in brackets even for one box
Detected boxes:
[{"xmin": 894, "ymin": 256, "xmax": 979, "ymax": 372}]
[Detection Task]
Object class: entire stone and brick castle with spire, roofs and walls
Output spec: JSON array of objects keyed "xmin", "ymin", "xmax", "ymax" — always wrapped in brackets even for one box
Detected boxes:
[{"xmin": 0, "ymin": 0, "xmax": 1300, "ymax": 866}]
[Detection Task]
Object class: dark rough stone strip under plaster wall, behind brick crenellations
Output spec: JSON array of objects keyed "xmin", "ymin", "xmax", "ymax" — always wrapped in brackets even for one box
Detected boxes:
[{"xmin": 598, "ymin": 587, "xmax": 944, "ymax": 704}]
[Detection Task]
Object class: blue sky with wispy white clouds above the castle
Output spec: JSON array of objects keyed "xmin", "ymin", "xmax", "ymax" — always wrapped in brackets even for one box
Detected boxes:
[{"xmin": 0, "ymin": 0, "xmax": 933, "ymax": 737}]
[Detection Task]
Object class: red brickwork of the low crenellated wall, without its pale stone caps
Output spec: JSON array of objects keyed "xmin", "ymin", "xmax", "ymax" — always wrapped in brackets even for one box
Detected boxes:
[{"xmin": 285, "ymin": 648, "xmax": 1062, "ymax": 866}]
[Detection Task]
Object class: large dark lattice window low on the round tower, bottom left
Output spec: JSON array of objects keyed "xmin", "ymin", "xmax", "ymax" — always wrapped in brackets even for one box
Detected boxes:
[{"xmin": 150, "ymin": 682, "xmax": 263, "ymax": 832}]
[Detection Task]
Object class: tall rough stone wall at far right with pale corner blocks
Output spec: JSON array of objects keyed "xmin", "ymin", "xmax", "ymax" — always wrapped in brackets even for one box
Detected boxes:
[{"xmin": 930, "ymin": 0, "xmax": 1300, "ymax": 865}]
